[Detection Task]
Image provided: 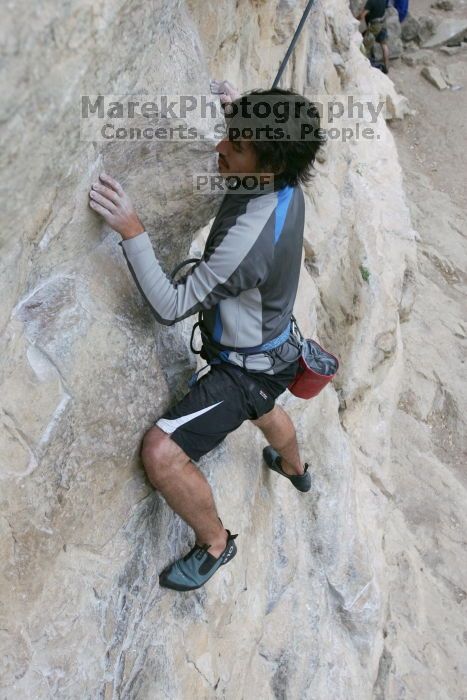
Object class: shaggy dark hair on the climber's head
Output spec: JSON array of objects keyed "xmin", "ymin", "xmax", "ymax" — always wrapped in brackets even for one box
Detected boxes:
[{"xmin": 225, "ymin": 88, "xmax": 326, "ymax": 186}]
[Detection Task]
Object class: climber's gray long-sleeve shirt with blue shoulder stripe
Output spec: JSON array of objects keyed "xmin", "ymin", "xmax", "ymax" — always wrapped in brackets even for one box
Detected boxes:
[{"xmin": 121, "ymin": 178, "xmax": 304, "ymax": 374}]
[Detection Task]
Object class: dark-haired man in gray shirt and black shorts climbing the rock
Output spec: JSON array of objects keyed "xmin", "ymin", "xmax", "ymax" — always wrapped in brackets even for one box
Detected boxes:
[{"xmin": 89, "ymin": 81, "xmax": 325, "ymax": 591}]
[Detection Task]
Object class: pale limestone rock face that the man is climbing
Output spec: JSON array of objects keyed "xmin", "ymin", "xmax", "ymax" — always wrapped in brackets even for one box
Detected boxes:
[{"xmin": 0, "ymin": 0, "xmax": 460, "ymax": 700}]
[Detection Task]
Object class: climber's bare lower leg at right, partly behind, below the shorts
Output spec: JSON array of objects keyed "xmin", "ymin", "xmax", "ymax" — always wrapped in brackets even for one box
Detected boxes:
[{"xmin": 252, "ymin": 406, "xmax": 303, "ymax": 475}]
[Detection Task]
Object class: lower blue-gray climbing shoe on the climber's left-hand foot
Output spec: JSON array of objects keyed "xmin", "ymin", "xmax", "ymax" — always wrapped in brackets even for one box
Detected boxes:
[{"xmin": 159, "ymin": 530, "xmax": 237, "ymax": 591}]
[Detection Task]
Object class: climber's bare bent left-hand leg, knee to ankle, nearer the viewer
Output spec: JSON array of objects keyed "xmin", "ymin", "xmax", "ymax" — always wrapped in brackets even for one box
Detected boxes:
[{"xmin": 141, "ymin": 427, "xmax": 227, "ymax": 557}]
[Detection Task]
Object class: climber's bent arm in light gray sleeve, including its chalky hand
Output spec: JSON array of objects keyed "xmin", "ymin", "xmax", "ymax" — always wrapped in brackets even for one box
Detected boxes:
[{"xmin": 89, "ymin": 173, "xmax": 274, "ymax": 326}]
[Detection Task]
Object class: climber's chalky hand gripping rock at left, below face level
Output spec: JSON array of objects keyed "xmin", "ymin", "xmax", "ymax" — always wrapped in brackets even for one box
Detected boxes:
[{"xmin": 89, "ymin": 173, "xmax": 145, "ymax": 239}]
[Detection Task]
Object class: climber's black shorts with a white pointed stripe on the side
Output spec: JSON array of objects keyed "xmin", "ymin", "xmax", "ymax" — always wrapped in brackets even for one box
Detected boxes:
[{"xmin": 155, "ymin": 361, "xmax": 298, "ymax": 461}]
